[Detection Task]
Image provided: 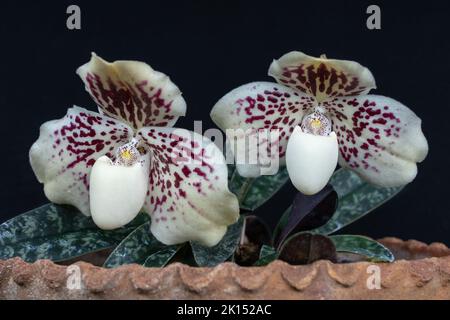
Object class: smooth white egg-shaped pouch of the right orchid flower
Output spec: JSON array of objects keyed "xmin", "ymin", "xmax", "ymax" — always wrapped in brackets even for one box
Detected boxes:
[{"xmin": 286, "ymin": 126, "xmax": 338, "ymax": 195}]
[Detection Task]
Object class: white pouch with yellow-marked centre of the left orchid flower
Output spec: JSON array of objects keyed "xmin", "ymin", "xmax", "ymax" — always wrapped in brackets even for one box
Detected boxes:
[{"xmin": 89, "ymin": 146, "xmax": 150, "ymax": 230}]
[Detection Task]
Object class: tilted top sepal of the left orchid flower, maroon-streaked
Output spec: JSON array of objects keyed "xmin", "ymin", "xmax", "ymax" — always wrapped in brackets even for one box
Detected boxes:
[{"xmin": 77, "ymin": 54, "xmax": 186, "ymax": 129}]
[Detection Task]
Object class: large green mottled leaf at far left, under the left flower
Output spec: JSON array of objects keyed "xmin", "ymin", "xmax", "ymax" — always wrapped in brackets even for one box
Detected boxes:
[{"xmin": 0, "ymin": 203, "xmax": 148, "ymax": 262}]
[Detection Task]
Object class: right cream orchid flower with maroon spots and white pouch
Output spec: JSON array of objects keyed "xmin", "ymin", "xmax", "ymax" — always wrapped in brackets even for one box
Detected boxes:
[{"xmin": 211, "ymin": 52, "xmax": 428, "ymax": 194}]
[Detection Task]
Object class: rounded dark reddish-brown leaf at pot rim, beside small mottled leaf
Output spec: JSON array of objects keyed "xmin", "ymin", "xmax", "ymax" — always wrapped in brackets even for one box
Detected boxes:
[{"xmin": 278, "ymin": 232, "xmax": 336, "ymax": 264}]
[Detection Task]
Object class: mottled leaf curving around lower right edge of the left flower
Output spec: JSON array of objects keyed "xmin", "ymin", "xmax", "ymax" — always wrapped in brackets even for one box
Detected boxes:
[{"xmin": 191, "ymin": 215, "xmax": 244, "ymax": 267}]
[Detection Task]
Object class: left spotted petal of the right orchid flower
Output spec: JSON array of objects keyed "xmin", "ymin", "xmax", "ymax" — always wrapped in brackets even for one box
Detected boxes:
[{"xmin": 211, "ymin": 82, "xmax": 314, "ymax": 177}]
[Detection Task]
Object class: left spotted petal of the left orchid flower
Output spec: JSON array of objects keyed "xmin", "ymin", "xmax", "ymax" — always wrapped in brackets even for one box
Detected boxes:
[{"xmin": 30, "ymin": 107, "xmax": 133, "ymax": 215}]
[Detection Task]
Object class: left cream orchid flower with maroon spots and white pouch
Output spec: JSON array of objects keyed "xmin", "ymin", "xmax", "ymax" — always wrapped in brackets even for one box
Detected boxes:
[{"xmin": 30, "ymin": 54, "xmax": 239, "ymax": 246}]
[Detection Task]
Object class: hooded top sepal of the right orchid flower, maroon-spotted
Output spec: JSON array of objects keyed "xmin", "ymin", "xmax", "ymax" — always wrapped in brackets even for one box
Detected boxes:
[{"xmin": 269, "ymin": 51, "xmax": 376, "ymax": 102}]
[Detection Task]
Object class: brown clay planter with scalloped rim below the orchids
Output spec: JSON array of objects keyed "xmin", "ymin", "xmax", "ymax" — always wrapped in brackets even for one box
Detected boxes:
[{"xmin": 0, "ymin": 238, "xmax": 450, "ymax": 299}]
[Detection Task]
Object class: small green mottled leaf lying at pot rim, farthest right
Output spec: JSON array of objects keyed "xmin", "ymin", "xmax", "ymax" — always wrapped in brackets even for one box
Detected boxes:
[{"xmin": 330, "ymin": 235, "xmax": 394, "ymax": 262}]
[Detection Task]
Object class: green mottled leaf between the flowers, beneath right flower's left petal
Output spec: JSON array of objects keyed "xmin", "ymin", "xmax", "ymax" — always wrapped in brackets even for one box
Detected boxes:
[{"xmin": 229, "ymin": 167, "xmax": 289, "ymax": 211}]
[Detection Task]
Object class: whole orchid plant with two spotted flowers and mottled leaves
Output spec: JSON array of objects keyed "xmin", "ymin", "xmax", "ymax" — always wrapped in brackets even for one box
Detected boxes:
[{"xmin": 0, "ymin": 52, "xmax": 428, "ymax": 267}]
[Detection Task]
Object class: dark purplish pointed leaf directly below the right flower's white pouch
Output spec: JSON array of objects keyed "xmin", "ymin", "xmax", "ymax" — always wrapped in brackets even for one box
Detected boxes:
[{"xmin": 274, "ymin": 185, "xmax": 337, "ymax": 247}]
